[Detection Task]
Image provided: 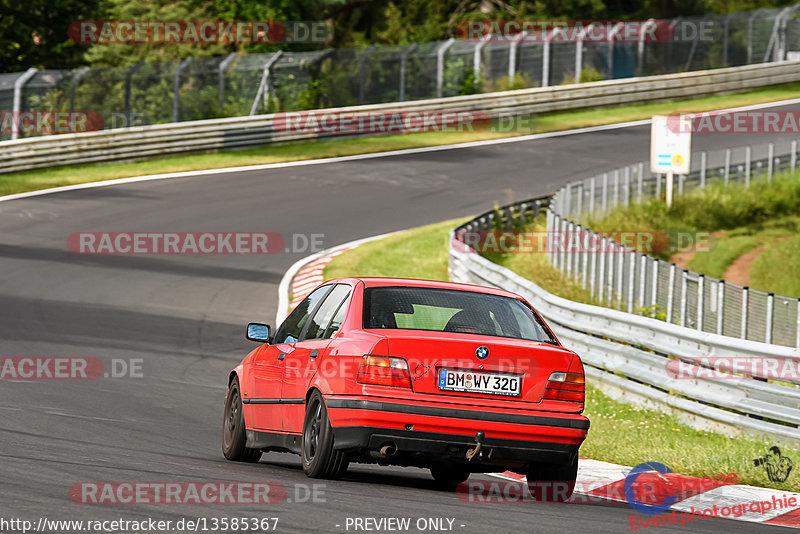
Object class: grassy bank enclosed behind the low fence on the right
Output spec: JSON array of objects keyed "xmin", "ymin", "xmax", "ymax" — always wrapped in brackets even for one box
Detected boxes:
[{"xmin": 586, "ymin": 173, "xmax": 800, "ymax": 296}]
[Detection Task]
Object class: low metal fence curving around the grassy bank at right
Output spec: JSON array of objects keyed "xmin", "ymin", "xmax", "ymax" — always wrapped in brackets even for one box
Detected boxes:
[{"xmin": 547, "ymin": 140, "xmax": 800, "ymax": 348}]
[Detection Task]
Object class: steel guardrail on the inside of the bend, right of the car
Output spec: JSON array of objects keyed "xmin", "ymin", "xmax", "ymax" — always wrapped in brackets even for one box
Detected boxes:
[{"xmin": 450, "ymin": 197, "xmax": 800, "ymax": 444}]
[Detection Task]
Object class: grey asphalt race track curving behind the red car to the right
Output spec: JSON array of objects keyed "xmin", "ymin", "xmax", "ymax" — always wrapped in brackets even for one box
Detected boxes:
[{"xmin": 0, "ymin": 101, "xmax": 800, "ymax": 533}]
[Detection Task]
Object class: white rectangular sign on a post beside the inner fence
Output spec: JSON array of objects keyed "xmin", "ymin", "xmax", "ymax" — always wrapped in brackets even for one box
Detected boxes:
[{"xmin": 650, "ymin": 115, "xmax": 692, "ymax": 207}]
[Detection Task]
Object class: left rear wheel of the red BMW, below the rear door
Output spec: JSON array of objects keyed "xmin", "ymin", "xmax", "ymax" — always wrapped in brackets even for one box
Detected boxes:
[{"xmin": 301, "ymin": 391, "xmax": 350, "ymax": 479}]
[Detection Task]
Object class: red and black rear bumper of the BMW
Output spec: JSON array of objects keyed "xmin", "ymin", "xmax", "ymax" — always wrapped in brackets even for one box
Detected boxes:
[{"xmin": 325, "ymin": 396, "xmax": 589, "ymax": 465}]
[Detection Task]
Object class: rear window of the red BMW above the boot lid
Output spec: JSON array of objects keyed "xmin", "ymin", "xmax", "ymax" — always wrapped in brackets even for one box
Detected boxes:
[{"xmin": 364, "ymin": 286, "xmax": 557, "ymax": 344}]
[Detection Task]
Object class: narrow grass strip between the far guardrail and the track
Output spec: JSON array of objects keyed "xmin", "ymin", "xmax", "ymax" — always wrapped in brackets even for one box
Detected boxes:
[{"xmin": 0, "ymin": 83, "xmax": 800, "ymax": 195}]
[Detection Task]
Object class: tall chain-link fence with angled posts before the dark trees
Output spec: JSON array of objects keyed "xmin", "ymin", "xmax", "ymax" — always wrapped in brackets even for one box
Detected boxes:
[{"xmin": 0, "ymin": 4, "xmax": 800, "ymax": 140}]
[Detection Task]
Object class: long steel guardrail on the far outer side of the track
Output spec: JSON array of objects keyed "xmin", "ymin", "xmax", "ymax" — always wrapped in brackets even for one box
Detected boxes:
[{"xmin": 0, "ymin": 61, "xmax": 800, "ymax": 173}]
